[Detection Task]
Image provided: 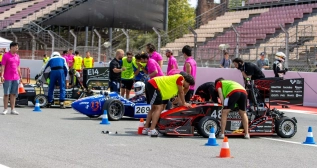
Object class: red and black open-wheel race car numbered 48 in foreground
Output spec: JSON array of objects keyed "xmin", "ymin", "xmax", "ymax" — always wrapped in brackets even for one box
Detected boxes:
[{"xmin": 156, "ymin": 78, "xmax": 297, "ymax": 138}]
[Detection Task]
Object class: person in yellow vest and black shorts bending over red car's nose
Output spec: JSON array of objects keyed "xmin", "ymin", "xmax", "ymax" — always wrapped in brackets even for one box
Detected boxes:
[{"xmin": 142, "ymin": 73, "xmax": 195, "ymax": 136}]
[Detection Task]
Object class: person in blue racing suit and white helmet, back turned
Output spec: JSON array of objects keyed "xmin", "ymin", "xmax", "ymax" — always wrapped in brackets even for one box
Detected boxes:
[{"xmin": 41, "ymin": 52, "xmax": 69, "ymax": 108}]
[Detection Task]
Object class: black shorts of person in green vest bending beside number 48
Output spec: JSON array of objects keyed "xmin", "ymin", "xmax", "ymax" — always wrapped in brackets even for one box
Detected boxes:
[{"xmin": 223, "ymin": 92, "xmax": 247, "ymax": 111}]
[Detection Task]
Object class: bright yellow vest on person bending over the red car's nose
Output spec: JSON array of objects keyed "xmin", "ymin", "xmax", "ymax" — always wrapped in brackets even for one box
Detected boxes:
[{"xmin": 153, "ymin": 74, "xmax": 182, "ymax": 100}]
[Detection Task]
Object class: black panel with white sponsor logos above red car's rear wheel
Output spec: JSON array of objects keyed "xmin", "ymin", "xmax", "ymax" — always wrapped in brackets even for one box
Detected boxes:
[{"xmin": 270, "ymin": 78, "xmax": 304, "ymax": 105}]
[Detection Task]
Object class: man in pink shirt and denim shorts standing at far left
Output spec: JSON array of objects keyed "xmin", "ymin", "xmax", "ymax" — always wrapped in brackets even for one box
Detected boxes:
[{"xmin": 1, "ymin": 42, "xmax": 22, "ymax": 115}]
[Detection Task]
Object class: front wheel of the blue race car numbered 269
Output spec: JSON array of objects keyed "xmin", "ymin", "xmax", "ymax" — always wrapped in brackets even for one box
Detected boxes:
[{"xmin": 103, "ymin": 99, "xmax": 124, "ymax": 121}]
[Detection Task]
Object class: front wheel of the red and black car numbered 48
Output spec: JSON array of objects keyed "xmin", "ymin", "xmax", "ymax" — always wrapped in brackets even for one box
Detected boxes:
[{"xmin": 197, "ymin": 116, "xmax": 220, "ymax": 138}]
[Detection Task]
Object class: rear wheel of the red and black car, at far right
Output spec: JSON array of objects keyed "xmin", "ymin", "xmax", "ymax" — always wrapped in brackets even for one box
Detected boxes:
[{"xmin": 275, "ymin": 117, "xmax": 297, "ymax": 138}]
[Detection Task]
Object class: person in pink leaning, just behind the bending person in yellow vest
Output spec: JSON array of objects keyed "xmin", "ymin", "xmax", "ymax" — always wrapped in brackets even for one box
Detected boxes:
[{"xmin": 141, "ymin": 53, "xmax": 164, "ymax": 79}]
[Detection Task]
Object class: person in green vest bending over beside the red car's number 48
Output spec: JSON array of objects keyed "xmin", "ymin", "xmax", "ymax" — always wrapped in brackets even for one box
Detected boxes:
[{"xmin": 215, "ymin": 78, "xmax": 250, "ymax": 139}]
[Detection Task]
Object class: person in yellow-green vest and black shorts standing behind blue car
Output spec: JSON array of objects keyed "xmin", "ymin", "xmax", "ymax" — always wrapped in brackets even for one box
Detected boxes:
[{"xmin": 121, "ymin": 52, "xmax": 135, "ymax": 99}]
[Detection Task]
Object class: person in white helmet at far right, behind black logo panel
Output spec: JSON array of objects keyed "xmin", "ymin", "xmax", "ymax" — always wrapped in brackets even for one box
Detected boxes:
[{"xmin": 273, "ymin": 52, "xmax": 288, "ymax": 78}]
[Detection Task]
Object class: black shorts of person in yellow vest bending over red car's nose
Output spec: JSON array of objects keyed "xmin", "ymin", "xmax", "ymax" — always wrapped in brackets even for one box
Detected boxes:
[{"xmin": 145, "ymin": 83, "xmax": 168, "ymax": 105}]
